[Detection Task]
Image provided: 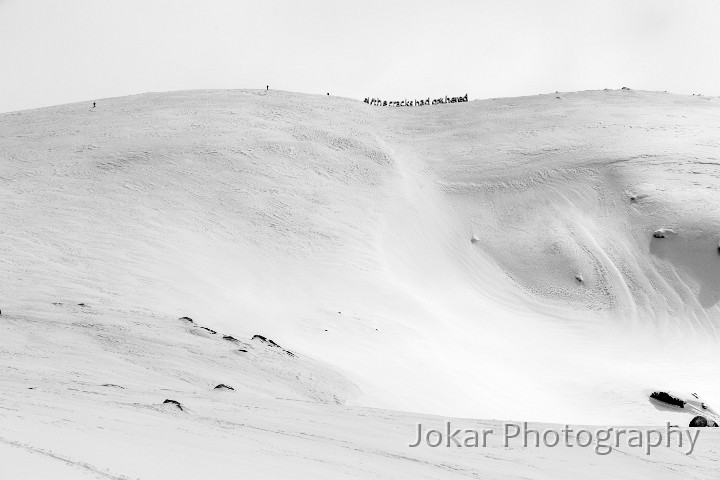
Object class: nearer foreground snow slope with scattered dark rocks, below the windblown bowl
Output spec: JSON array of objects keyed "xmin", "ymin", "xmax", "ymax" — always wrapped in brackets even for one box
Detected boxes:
[{"xmin": 0, "ymin": 305, "xmax": 720, "ymax": 480}]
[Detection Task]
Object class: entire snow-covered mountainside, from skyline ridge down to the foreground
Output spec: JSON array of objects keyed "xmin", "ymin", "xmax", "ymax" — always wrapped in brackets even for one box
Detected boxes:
[{"xmin": 0, "ymin": 90, "xmax": 720, "ymax": 480}]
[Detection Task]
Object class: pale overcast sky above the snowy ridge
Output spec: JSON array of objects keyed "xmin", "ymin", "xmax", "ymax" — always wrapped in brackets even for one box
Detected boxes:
[{"xmin": 0, "ymin": 0, "xmax": 720, "ymax": 112}]
